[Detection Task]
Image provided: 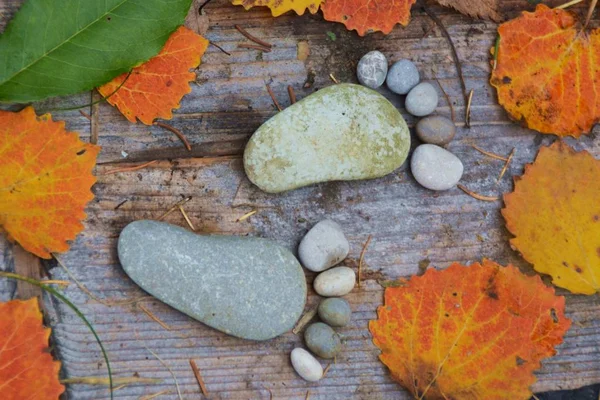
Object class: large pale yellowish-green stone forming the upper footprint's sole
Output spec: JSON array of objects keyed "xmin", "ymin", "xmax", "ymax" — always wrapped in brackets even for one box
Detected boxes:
[{"xmin": 244, "ymin": 84, "xmax": 410, "ymax": 193}]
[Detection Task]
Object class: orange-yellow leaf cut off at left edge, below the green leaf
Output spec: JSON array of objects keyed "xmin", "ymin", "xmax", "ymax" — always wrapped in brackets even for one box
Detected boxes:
[{"xmin": 0, "ymin": 107, "xmax": 100, "ymax": 258}]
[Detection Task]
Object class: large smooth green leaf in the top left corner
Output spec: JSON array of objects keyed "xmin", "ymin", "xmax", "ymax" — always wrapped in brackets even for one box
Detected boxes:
[{"xmin": 0, "ymin": 0, "xmax": 192, "ymax": 103}]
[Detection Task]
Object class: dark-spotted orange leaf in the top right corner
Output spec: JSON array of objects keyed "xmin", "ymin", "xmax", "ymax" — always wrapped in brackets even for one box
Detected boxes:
[{"xmin": 491, "ymin": 4, "xmax": 600, "ymax": 137}]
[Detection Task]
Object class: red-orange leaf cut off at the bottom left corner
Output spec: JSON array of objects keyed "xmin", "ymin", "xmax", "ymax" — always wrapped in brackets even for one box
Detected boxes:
[{"xmin": 0, "ymin": 298, "xmax": 65, "ymax": 400}]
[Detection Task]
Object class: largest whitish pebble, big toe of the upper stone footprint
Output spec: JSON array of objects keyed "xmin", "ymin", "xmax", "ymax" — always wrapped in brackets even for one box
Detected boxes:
[{"xmin": 410, "ymin": 144, "xmax": 463, "ymax": 190}]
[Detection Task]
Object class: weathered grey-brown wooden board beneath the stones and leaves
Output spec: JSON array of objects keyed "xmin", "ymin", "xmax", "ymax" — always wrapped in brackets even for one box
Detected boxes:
[{"xmin": 0, "ymin": 0, "xmax": 600, "ymax": 400}]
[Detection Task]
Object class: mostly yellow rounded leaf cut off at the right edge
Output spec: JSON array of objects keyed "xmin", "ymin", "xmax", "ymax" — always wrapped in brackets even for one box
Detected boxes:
[{"xmin": 502, "ymin": 141, "xmax": 600, "ymax": 294}]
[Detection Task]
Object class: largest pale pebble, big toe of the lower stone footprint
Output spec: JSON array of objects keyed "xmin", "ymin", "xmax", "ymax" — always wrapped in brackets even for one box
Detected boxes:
[{"xmin": 298, "ymin": 219, "xmax": 350, "ymax": 272}]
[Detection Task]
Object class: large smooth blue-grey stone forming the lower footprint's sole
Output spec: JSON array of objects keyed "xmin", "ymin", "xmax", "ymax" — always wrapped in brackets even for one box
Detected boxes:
[{"xmin": 118, "ymin": 221, "xmax": 306, "ymax": 340}]
